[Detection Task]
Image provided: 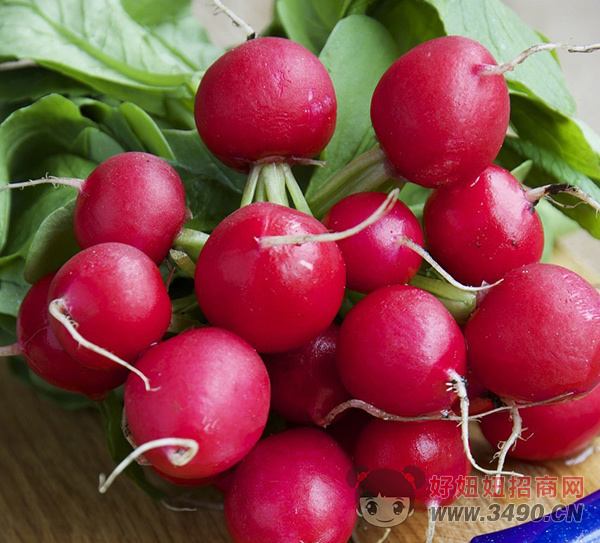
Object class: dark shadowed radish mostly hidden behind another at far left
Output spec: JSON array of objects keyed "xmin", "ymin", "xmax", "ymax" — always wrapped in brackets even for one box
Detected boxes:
[{"xmin": 17, "ymin": 275, "xmax": 128, "ymax": 401}]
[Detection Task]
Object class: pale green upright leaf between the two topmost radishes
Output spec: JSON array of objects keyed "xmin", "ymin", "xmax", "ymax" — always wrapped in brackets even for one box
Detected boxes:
[{"xmin": 307, "ymin": 15, "xmax": 398, "ymax": 196}]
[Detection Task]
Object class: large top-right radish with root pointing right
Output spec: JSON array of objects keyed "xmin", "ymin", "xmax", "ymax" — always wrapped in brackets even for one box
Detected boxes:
[{"xmin": 371, "ymin": 36, "xmax": 510, "ymax": 187}]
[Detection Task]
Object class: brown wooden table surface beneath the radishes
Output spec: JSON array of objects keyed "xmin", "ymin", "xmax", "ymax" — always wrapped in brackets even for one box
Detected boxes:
[{"xmin": 0, "ymin": 233, "xmax": 600, "ymax": 543}]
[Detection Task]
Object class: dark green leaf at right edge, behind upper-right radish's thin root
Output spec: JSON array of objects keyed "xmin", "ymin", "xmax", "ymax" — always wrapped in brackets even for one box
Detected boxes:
[{"xmin": 500, "ymin": 137, "xmax": 600, "ymax": 238}]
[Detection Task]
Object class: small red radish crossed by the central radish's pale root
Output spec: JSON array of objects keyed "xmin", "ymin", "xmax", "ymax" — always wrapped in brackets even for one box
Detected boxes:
[{"xmin": 323, "ymin": 192, "xmax": 423, "ymax": 293}]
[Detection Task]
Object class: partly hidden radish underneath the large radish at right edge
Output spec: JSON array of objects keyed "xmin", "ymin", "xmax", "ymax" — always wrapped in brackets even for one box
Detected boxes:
[{"xmin": 481, "ymin": 387, "xmax": 600, "ymax": 460}]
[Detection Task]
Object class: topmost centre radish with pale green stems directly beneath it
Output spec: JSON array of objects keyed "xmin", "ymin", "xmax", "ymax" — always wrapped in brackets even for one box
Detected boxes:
[{"xmin": 195, "ymin": 37, "xmax": 337, "ymax": 170}]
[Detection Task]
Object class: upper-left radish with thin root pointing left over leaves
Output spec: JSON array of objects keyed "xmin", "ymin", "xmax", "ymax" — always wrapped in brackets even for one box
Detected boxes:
[{"xmin": 73, "ymin": 152, "xmax": 185, "ymax": 264}]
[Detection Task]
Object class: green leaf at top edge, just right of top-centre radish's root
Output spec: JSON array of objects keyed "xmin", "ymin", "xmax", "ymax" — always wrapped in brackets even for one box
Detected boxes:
[{"xmin": 275, "ymin": 0, "xmax": 373, "ymax": 55}]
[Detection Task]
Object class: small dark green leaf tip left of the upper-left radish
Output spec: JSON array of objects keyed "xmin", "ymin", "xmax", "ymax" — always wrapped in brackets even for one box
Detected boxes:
[{"xmin": 23, "ymin": 200, "xmax": 80, "ymax": 284}]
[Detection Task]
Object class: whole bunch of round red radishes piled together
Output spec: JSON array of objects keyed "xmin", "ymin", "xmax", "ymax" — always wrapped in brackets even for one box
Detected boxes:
[{"xmin": 1, "ymin": 18, "xmax": 600, "ymax": 543}]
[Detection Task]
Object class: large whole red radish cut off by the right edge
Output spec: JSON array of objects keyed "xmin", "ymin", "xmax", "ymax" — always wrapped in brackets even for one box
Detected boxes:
[{"xmin": 465, "ymin": 264, "xmax": 600, "ymax": 402}]
